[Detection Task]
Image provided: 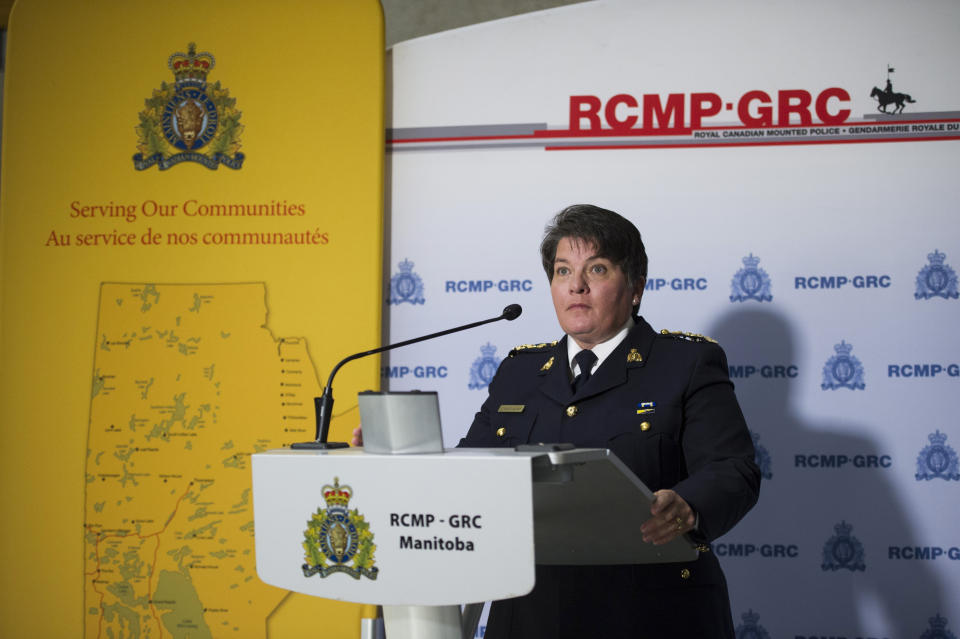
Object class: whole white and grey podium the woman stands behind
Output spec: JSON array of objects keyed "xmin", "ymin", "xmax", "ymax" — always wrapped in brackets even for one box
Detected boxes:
[{"xmin": 253, "ymin": 448, "xmax": 697, "ymax": 639}]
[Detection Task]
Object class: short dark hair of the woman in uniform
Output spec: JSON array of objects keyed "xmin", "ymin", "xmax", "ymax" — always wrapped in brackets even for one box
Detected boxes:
[{"xmin": 540, "ymin": 204, "xmax": 647, "ymax": 286}]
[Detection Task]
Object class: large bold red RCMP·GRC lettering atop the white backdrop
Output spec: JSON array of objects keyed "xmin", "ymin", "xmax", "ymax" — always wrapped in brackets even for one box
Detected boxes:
[{"xmin": 570, "ymin": 87, "xmax": 850, "ymax": 133}]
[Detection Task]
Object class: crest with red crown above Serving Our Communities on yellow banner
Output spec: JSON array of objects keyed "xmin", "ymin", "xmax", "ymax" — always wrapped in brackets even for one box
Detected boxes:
[{"xmin": 133, "ymin": 42, "xmax": 244, "ymax": 171}]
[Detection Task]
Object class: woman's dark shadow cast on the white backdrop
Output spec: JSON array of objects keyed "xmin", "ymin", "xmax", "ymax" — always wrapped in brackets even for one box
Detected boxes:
[{"xmin": 707, "ymin": 309, "xmax": 947, "ymax": 639}]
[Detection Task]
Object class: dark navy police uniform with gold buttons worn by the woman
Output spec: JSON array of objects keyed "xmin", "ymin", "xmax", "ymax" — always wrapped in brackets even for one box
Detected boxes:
[{"xmin": 460, "ymin": 318, "xmax": 760, "ymax": 639}]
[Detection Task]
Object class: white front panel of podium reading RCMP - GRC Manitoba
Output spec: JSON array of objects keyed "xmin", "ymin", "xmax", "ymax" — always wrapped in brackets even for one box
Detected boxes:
[{"xmin": 253, "ymin": 449, "xmax": 534, "ymax": 606}]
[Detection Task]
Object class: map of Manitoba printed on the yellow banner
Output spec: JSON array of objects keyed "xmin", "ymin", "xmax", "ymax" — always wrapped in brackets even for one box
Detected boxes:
[{"xmin": 84, "ymin": 283, "xmax": 320, "ymax": 639}]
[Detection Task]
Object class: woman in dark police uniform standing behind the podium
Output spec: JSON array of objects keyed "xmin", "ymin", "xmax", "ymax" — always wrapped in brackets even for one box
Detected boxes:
[{"xmin": 460, "ymin": 205, "xmax": 760, "ymax": 639}]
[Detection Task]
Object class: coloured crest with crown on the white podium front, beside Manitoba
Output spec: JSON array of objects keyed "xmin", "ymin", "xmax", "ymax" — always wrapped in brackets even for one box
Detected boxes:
[{"xmin": 303, "ymin": 477, "xmax": 380, "ymax": 579}]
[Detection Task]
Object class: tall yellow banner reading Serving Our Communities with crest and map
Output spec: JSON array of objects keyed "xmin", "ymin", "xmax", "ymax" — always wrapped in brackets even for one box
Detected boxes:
[{"xmin": 0, "ymin": 0, "xmax": 383, "ymax": 639}]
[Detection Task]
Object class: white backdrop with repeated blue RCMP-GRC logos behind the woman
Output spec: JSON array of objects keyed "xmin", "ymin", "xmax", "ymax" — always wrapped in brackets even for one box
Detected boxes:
[{"xmin": 382, "ymin": 0, "xmax": 960, "ymax": 638}]
